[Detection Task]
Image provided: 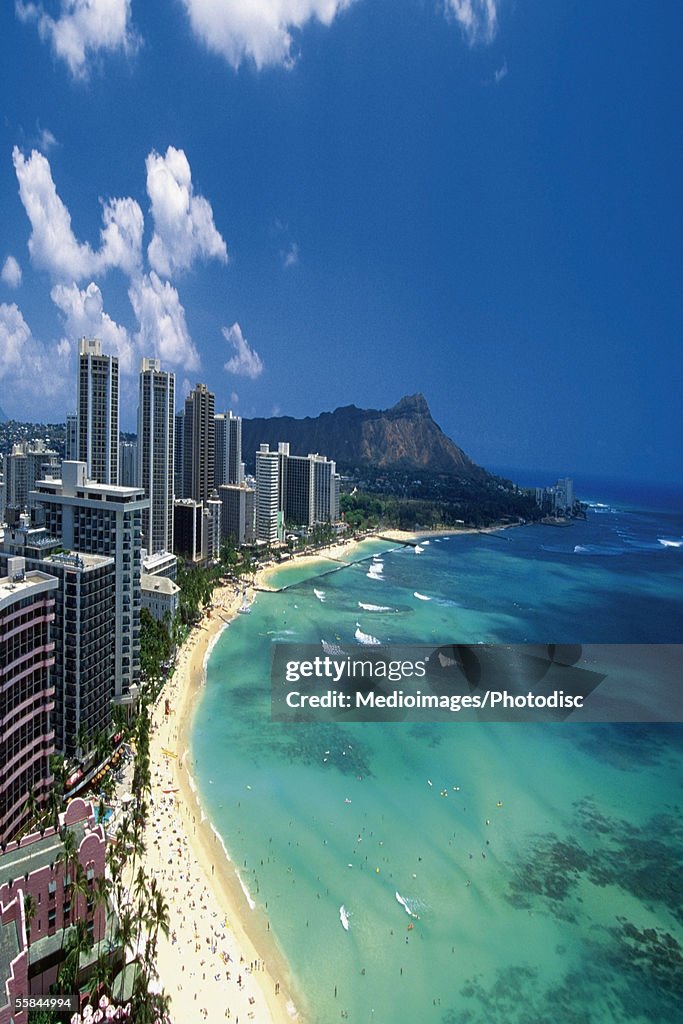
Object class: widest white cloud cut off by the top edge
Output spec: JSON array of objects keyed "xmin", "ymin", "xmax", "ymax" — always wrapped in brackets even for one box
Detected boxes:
[{"xmin": 183, "ymin": 0, "xmax": 354, "ymax": 69}]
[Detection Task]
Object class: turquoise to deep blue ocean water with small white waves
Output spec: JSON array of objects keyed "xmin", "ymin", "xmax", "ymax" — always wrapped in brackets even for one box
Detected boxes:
[{"xmin": 191, "ymin": 493, "xmax": 683, "ymax": 1024}]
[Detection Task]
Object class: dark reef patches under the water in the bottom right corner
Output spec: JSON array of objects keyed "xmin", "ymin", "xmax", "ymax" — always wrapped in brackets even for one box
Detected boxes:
[{"xmin": 466, "ymin": 797, "xmax": 683, "ymax": 1024}]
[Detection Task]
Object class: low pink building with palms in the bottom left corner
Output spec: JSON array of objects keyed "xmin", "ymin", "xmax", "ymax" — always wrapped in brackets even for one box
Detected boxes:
[{"xmin": 0, "ymin": 798, "xmax": 106, "ymax": 1024}]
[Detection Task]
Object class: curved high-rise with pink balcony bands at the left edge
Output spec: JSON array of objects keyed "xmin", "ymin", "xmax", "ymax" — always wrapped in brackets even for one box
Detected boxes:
[{"xmin": 0, "ymin": 557, "xmax": 58, "ymax": 843}]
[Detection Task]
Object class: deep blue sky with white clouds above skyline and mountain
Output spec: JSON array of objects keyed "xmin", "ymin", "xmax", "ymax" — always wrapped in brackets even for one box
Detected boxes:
[{"xmin": 0, "ymin": 0, "xmax": 683, "ymax": 482}]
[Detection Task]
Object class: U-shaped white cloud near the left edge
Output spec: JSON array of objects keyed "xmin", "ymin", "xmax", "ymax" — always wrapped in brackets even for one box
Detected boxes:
[{"xmin": 12, "ymin": 146, "xmax": 143, "ymax": 281}]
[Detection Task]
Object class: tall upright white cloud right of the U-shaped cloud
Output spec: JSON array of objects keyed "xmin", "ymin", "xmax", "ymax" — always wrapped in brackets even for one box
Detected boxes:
[{"xmin": 145, "ymin": 145, "xmax": 227, "ymax": 276}]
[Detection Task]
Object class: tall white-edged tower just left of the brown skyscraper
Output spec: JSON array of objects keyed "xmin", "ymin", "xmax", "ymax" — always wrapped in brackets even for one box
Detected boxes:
[{"xmin": 137, "ymin": 359, "xmax": 175, "ymax": 554}]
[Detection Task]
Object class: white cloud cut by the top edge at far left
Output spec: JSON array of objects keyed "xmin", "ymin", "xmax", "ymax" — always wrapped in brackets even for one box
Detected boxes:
[{"xmin": 15, "ymin": 0, "xmax": 137, "ymax": 78}]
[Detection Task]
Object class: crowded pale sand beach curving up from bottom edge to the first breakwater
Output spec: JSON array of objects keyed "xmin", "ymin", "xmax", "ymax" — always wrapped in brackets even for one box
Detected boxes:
[{"xmin": 144, "ymin": 573, "xmax": 305, "ymax": 1024}]
